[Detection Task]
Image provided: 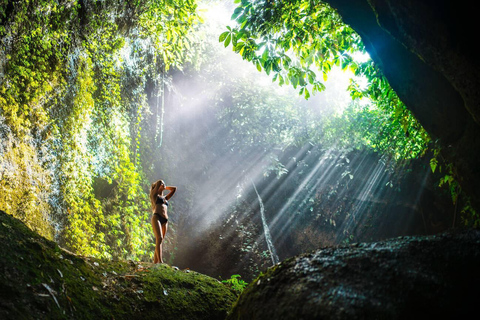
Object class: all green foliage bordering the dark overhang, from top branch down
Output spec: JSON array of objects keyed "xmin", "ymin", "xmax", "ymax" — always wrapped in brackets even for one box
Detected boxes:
[{"xmin": 219, "ymin": 0, "xmax": 476, "ymax": 226}]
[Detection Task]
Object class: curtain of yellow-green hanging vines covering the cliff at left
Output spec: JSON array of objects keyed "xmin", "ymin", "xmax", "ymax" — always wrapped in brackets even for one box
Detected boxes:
[{"xmin": 0, "ymin": 0, "xmax": 198, "ymax": 259}]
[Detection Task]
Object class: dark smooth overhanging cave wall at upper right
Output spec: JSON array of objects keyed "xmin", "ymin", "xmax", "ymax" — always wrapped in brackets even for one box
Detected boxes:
[{"xmin": 328, "ymin": 0, "xmax": 480, "ymax": 210}]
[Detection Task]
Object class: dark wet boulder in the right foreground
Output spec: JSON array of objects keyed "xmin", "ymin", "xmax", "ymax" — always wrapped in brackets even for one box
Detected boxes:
[{"xmin": 228, "ymin": 230, "xmax": 480, "ymax": 319}]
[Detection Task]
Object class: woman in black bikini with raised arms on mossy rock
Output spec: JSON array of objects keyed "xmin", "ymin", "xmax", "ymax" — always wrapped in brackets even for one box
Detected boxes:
[{"xmin": 150, "ymin": 180, "xmax": 177, "ymax": 263}]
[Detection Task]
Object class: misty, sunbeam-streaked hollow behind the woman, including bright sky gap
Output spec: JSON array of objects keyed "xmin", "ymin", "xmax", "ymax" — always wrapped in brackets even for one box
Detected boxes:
[{"xmin": 146, "ymin": 2, "xmax": 446, "ymax": 278}]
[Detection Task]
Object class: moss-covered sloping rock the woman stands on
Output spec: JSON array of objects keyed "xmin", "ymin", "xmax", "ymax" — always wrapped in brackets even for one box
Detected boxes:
[{"xmin": 0, "ymin": 211, "xmax": 237, "ymax": 319}]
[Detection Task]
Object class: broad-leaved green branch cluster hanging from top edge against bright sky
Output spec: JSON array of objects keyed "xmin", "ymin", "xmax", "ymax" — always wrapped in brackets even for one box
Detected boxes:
[{"xmin": 219, "ymin": 1, "xmax": 364, "ymax": 98}]
